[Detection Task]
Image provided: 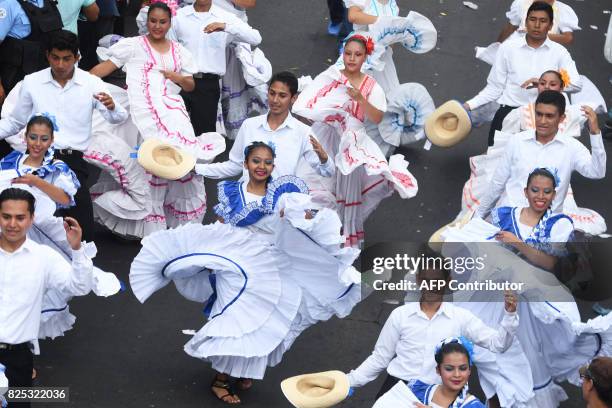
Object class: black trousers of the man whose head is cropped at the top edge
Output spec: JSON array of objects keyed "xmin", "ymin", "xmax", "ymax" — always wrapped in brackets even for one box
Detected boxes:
[{"xmin": 181, "ymin": 74, "xmax": 221, "ymax": 136}]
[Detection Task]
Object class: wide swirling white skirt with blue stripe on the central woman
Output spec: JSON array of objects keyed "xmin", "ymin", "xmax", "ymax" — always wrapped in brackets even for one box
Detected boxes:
[{"xmin": 130, "ymin": 201, "xmax": 361, "ymax": 379}]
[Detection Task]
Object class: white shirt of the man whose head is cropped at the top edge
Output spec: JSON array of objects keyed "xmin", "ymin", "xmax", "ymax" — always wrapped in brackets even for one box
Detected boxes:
[{"xmin": 169, "ymin": 4, "xmax": 261, "ymax": 76}]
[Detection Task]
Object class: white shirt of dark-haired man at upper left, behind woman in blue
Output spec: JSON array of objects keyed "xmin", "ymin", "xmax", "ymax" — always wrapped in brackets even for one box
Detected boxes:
[{"xmin": 0, "ymin": 68, "xmax": 128, "ymax": 151}]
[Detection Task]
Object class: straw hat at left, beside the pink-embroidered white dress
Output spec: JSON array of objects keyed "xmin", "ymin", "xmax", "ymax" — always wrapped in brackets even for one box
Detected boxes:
[{"xmin": 138, "ymin": 139, "xmax": 196, "ymax": 180}]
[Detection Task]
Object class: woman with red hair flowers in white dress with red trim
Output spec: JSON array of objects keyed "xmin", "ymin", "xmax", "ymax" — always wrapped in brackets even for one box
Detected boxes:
[{"xmin": 293, "ymin": 35, "xmax": 418, "ymax": 246}]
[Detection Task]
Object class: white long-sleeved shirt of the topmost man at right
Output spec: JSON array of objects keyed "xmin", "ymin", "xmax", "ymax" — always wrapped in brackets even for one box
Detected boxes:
[{"xmin": 467, "ymin": 37, "xmax": 582, "ymax": 110}]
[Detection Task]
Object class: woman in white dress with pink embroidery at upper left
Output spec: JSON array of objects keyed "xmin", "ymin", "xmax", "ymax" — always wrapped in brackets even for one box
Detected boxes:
[{"xmin": 91, "ymin": 3, "xmax": 225, "ymax": 238}]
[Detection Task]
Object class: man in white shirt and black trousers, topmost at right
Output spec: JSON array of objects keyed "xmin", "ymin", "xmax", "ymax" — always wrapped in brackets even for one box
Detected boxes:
[{"xmin": 464, "ymin": 1, "xmax": 582, "ymax": 146}]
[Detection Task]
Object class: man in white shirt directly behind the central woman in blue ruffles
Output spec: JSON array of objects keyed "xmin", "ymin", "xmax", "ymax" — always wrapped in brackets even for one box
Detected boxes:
[{"xmin": 195, "ymin": 72, "xmax": 336, "ymax": 179}]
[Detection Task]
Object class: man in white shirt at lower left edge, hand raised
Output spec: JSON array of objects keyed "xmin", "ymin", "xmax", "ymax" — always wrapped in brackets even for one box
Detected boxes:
[{"xmin": 0, "ymin": 188, "xmax": 93, "ymax": 407}]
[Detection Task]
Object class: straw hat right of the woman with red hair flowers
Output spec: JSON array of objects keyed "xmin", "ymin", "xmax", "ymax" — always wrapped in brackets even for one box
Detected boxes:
[{"xmin": 425, "ymin": 100, "xmax": 472, "ymax": 147}]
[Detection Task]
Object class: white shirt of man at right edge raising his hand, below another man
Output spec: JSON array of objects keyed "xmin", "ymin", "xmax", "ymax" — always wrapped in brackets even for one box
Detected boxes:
[{"xmin": 476, "ymin": 130, "xmax": 606, "ymax": 218}]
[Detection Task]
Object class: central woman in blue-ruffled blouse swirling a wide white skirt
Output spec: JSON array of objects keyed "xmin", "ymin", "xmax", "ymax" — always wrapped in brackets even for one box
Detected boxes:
[{"xmin": 130, "ymin": 142, "xmax": 361, "ymax": 403}]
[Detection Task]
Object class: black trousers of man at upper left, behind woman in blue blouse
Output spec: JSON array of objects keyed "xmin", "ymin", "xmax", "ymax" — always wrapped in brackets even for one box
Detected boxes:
[{"xmin": 55, "ymin": 151, "xmax": 94, "ymax": 242}]
